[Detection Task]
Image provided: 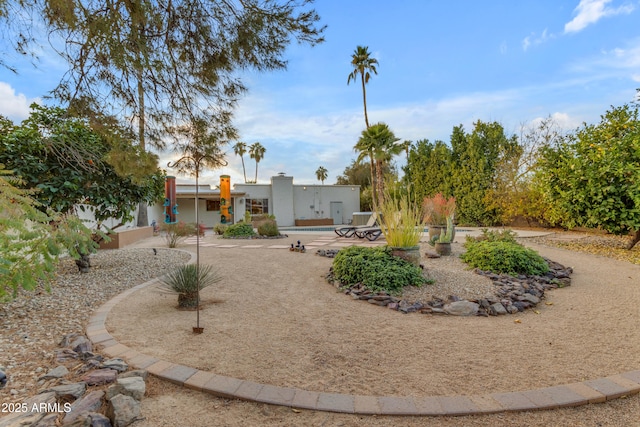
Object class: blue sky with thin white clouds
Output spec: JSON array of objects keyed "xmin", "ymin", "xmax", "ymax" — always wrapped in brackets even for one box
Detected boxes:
[{"xmin": 0, "ymin": 0, "xmax": 640, "ymax": 185}]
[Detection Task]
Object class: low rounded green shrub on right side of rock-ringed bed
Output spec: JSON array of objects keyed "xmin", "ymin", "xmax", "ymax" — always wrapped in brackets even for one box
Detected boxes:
[{"xmin": 460, "ymin": 240, "xmax": 549, "ymax": 275}]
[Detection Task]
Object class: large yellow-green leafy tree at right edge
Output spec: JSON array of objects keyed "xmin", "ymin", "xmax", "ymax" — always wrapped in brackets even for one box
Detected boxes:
[{"xmin": 537, "ymin": 105, "xmax": 640, "ymax": 249}]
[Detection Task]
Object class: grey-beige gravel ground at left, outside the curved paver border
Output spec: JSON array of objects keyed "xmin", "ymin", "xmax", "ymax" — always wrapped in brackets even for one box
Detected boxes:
[{"xmin": 0, "ymin": 249, "xmax": 191, "ymax": 402}]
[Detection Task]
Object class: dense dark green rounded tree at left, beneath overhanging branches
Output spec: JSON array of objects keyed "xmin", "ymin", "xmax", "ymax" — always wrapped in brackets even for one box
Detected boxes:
[{"xmin": 0, "ymin": 104, "xmax": 164, "ymax": 228}]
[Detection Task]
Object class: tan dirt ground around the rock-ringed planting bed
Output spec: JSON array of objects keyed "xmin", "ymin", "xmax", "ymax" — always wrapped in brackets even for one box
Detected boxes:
[{"xmin": 102, "ymin": 236, "xmax": 640, "ymax": 426}]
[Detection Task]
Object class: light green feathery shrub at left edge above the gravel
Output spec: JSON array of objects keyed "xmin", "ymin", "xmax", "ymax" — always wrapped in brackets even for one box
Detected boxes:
[{"xmin": 0, "ymin": 165, "xmax": 99, "ymax": 301}]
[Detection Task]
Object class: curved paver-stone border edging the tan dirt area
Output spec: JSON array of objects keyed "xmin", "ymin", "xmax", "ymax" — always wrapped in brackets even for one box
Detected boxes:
[{"xmin": 85, "ymin": 249, "xmax": 640, "ymax": 416}]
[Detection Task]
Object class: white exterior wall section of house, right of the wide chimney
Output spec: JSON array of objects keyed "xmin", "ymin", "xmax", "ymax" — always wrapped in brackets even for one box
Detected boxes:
[{"xmin": 293, "ymin": 185, "xmax": 360, "ymax": 225}]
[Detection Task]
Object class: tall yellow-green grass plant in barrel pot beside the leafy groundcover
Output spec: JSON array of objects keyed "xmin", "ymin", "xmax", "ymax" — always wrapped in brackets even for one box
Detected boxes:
[{"xmin": 378, "ymin": 191, "xmax": 424, "ymax": 266}]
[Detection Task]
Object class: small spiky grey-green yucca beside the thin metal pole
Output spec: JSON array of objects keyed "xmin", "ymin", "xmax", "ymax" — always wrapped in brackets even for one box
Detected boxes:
[{"xmin": 160, "ymin": 264, "xmax": 222, "ymax": 308}]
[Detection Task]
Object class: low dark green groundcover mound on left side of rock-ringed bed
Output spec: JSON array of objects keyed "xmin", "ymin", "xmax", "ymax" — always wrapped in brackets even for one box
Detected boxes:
[{"xmin": 333, "ymin": 246, "xmax": 426, "ymax": 294}]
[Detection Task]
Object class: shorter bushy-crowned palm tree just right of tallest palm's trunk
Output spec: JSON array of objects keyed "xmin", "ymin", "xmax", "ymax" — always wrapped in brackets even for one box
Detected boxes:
[{"xmin": 353, "ymin": 123, "xmax": 404, "ymax": 203}]
